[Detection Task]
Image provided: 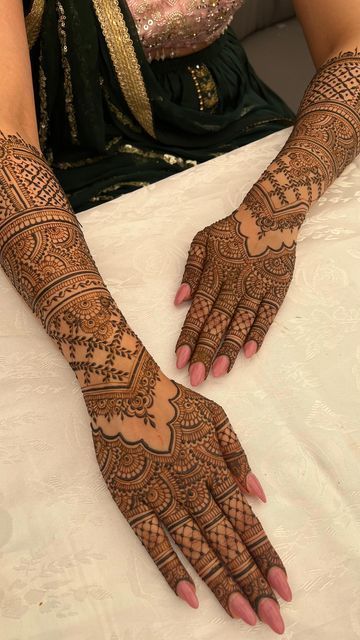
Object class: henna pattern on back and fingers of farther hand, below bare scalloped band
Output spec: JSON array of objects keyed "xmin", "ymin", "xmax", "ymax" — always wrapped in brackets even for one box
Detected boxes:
[{"xmin": 176, "ymin": 211, "xmax": 296, "ymax": 372}]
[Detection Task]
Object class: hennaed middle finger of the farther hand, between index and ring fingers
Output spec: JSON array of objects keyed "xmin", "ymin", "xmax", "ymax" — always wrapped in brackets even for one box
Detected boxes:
[{"xmin": 190, "ymin": 291, "xmax": 236, "ymax": 377}]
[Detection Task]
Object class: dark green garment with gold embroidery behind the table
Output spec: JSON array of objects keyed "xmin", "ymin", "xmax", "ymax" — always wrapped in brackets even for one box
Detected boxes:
[{"xmin": 27, "ymin": 0, "xmax": 295, "ymax": 212}]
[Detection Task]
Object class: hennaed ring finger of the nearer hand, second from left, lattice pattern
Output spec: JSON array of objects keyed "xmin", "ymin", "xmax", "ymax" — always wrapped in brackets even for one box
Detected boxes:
[{"xmin": 161, "ymin": 503, "xmax": 249, "ymax": 617}]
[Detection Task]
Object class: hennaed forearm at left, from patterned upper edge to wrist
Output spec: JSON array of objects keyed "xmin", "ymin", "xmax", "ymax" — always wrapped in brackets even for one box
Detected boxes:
[{"xmin": 0, "ymin": 130, "xmax": 148, "ymax": 402}]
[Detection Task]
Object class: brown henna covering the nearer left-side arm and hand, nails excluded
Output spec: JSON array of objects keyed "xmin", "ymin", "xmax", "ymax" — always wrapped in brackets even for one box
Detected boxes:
[{"xmin": 0, "ymin": 129, "xmax": 283, "ymax": 615}]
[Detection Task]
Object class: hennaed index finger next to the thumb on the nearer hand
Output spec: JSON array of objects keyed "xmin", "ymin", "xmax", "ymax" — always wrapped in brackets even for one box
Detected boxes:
[{"xmin": 211, "ymin": 470, "xmax": 286, "ymax": 597}]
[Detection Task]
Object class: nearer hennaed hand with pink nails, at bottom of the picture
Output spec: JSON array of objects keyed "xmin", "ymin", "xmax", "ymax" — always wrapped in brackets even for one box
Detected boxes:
[{"xmin": 83, "ymin": 334, "xmax": 291, "ymax": 633}]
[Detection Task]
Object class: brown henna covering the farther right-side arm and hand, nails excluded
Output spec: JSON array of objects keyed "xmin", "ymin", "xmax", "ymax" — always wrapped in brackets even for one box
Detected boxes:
[{"xmin": 175, "ymin": 48, "xmax": 360, "ymax": 375}]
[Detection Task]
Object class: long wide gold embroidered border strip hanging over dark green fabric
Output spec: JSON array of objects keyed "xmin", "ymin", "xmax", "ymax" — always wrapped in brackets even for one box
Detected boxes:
[{"xmin": 92, "ymin": 0, "xmax": 156, "ymax": 138}]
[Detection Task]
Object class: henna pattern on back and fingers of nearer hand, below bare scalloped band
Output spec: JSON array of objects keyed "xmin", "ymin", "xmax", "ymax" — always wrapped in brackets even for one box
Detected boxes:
[{"xmin": 92, "ymin": 381, "xmax": 283, "ymax": 615}]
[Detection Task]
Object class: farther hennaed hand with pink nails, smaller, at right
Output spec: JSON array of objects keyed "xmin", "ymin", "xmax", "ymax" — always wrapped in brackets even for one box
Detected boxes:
[{"xmin": 175, "ymin": 202, "xmax": 300, "ymax": 386}]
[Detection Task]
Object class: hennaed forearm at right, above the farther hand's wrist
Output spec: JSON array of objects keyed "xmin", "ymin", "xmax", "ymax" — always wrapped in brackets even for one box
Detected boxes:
[{"xmin": 239, "ymin": 49, "xmax": 360, "ymax": 248}]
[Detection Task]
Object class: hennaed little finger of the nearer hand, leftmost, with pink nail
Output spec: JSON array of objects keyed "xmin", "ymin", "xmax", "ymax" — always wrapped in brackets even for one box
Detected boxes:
[{"xmin": 127, "ymin": 504, "xmax": 199, "ymax": 608}]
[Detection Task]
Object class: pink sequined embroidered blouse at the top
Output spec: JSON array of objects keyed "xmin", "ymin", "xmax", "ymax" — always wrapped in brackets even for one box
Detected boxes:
[{"xmin": 128, "ymin": 0, "xmax": 244, "ymax": 62}]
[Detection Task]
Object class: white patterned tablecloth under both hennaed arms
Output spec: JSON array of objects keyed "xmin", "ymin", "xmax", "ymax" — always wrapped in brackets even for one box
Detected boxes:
[{"xmin": 0, "ymin": 129, "xmax": 360, "ymax": 640}]
